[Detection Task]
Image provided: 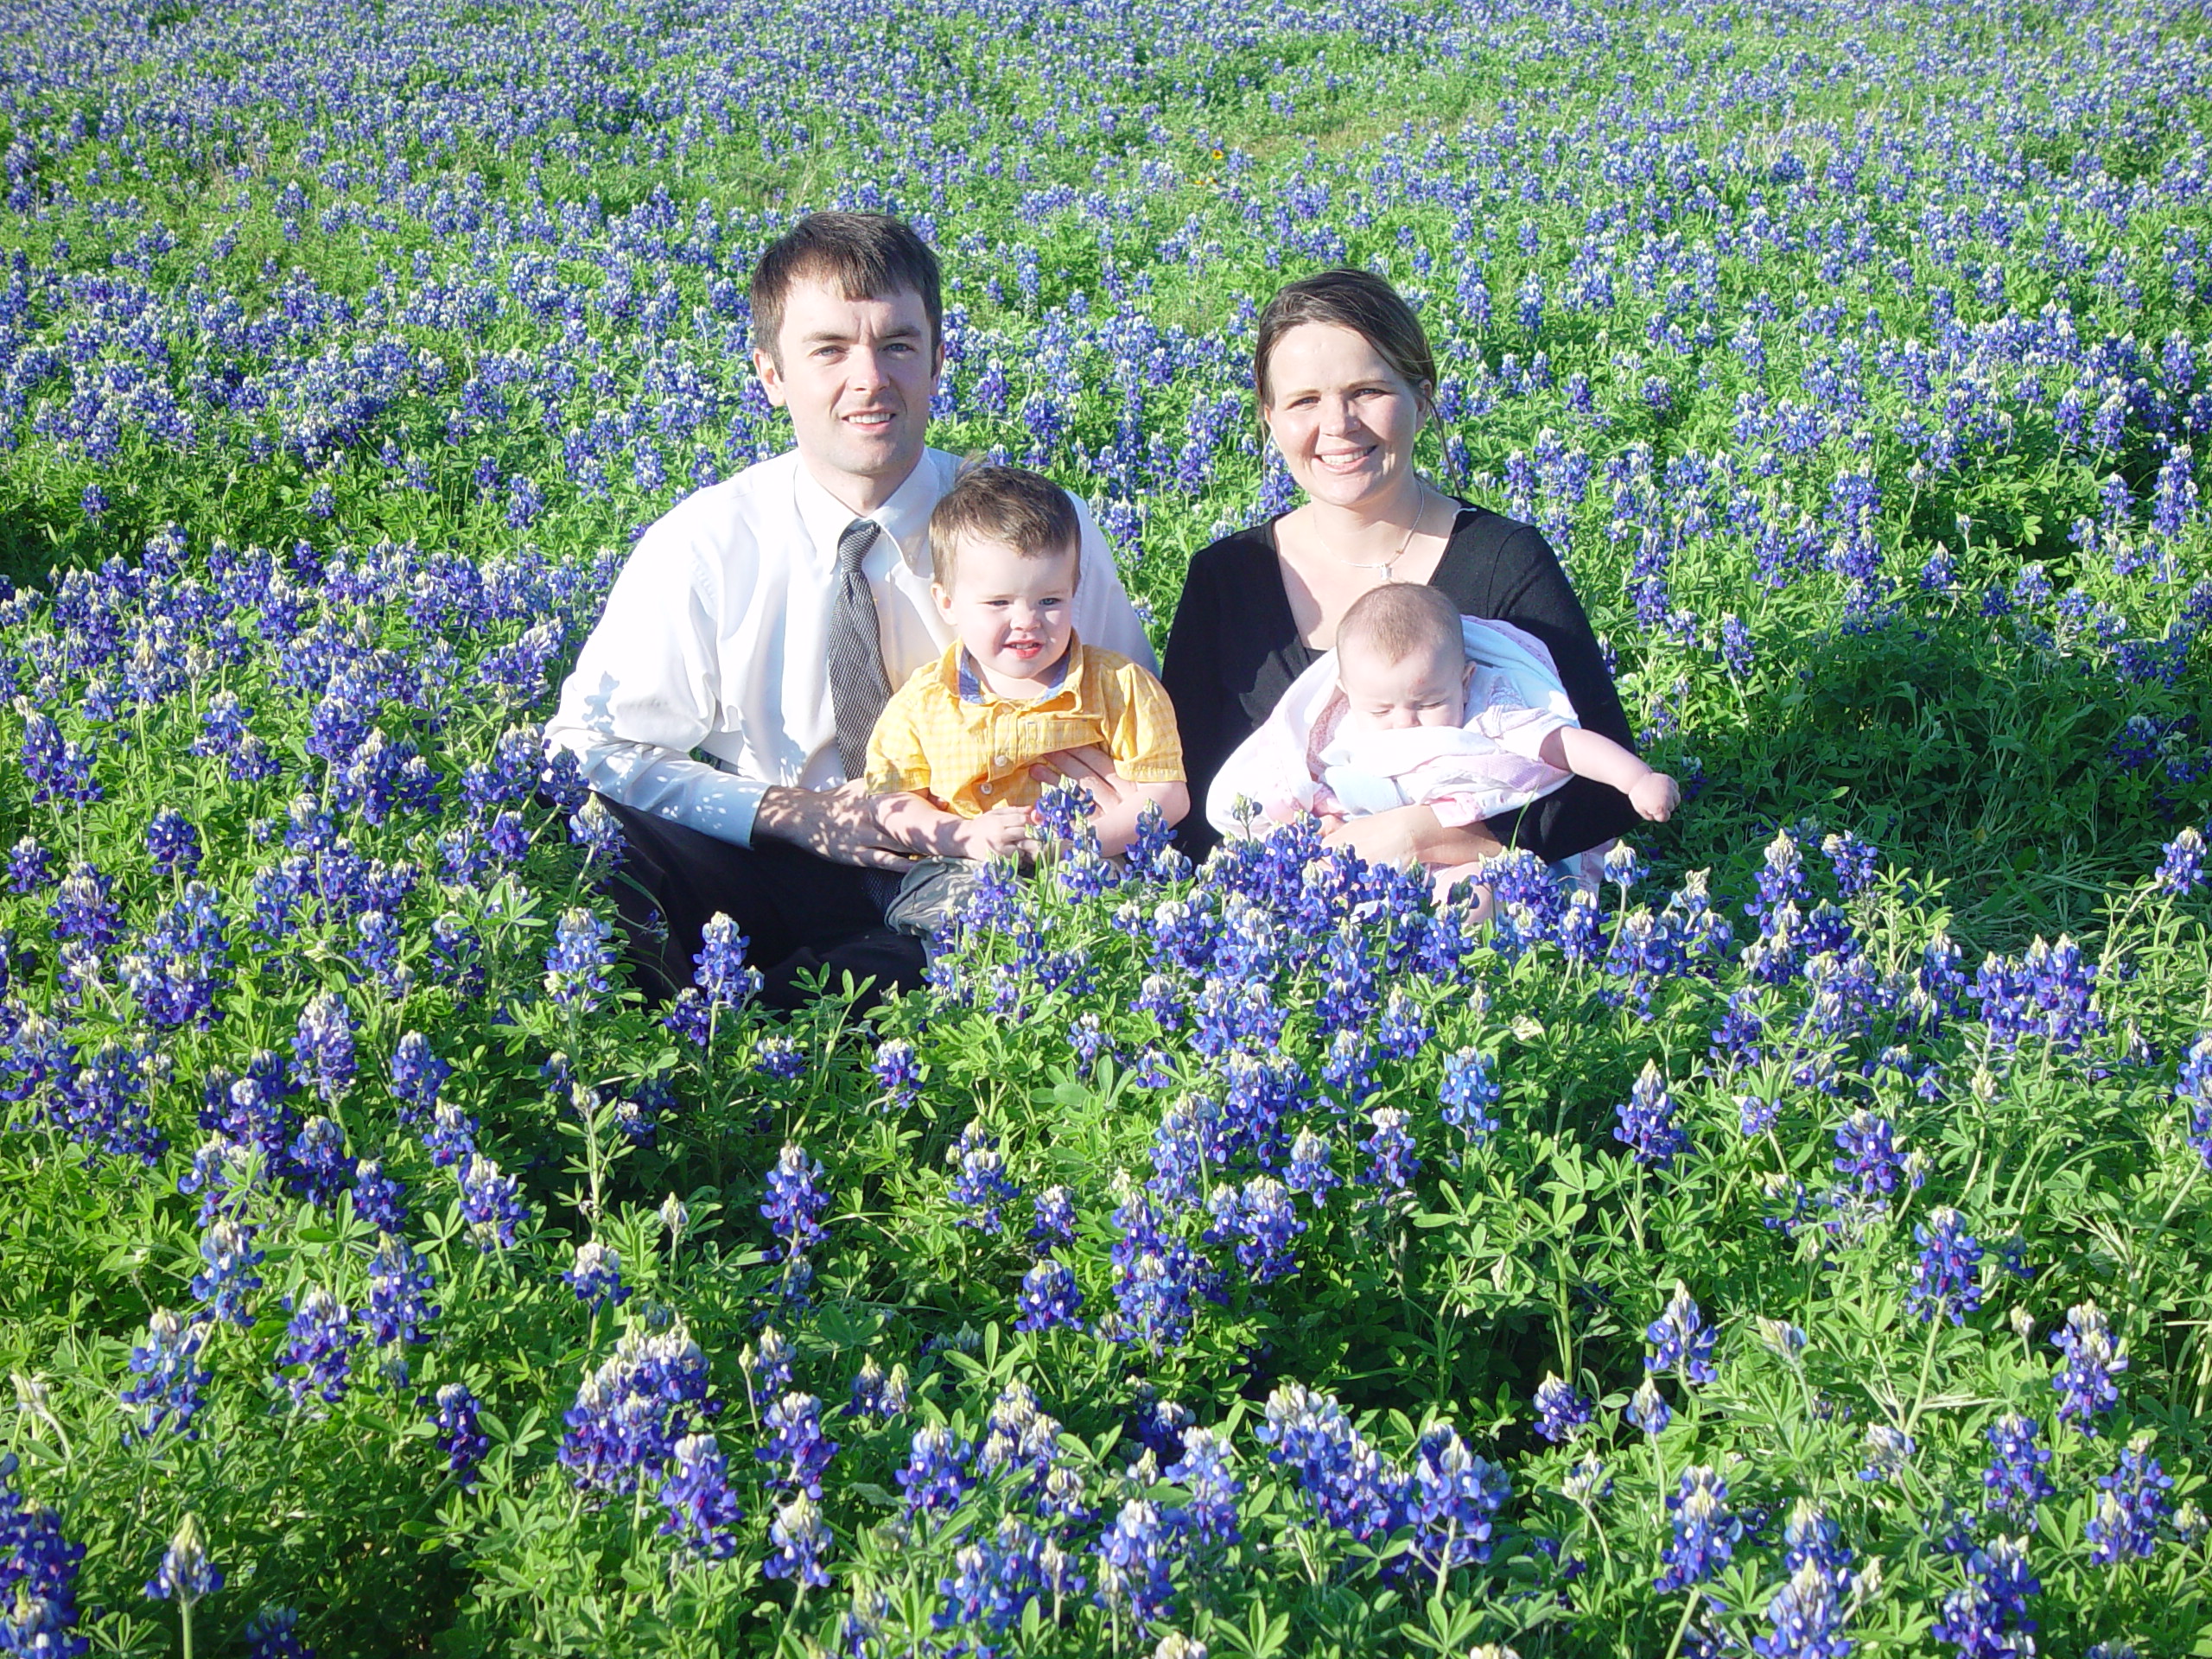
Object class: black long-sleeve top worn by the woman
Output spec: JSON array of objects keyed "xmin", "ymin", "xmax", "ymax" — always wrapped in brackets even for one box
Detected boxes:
[{"xmin": 1159, "ymin": 506, "xmax": 1637, "ymax": 858}]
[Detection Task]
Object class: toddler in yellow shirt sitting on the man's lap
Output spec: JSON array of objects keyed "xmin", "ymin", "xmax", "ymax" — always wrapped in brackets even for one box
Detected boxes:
[{"xmin": 868, "ymin": 467, "xmax": 1190, "ymax": 931}]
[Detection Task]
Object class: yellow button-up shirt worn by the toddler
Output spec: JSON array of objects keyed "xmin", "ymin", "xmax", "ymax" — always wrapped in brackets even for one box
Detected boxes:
[{"xmin": 868, "ymin": 639, "xmax": 1184, "ymax": 818}]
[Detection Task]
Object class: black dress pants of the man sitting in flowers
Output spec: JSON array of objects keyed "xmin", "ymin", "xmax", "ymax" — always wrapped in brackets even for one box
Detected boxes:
[{"xmin": 600, "ymin": 797, "xmax": 925, "ymax": 1011}]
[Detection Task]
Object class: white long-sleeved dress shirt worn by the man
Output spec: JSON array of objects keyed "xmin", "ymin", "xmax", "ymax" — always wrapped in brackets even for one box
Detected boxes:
[{"xmin": 546, "ymin": 449, "xmax": 1157, "ymax": 847}]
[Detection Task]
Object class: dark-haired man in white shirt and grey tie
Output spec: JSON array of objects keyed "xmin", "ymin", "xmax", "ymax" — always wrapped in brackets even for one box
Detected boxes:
[{"xmin": 546, "ymin": 213, "xmax": 1154, "ymax": 1007}]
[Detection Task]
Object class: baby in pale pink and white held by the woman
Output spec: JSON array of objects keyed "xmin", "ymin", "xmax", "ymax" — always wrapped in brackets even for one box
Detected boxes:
[{"xmin": 1205, "ymin": 582, "xmax": 1681, "ymax": 898}]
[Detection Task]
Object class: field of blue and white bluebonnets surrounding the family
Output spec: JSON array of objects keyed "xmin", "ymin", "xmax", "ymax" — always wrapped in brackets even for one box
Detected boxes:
[{"xmin": 0, "ymin": 0, "xmax": 2212, "ymax": 1659}]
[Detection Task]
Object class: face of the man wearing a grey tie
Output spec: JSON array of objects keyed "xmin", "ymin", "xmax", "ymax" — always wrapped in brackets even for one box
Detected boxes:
[{"xmin": 752, "ymin": 276, "xmax": 944, "ymax": 513}]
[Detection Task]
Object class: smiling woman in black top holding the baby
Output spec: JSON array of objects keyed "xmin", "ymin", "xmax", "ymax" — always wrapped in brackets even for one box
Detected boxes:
[{"xmin": 1161, "ymin": 270, "xmax": 1637, "ymax": 865}]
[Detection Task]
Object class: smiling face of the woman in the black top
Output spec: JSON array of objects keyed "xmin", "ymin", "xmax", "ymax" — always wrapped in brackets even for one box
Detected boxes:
[{"xmin": 1263, "ymin": 323, "xmax": 1429, "ymax": 506}]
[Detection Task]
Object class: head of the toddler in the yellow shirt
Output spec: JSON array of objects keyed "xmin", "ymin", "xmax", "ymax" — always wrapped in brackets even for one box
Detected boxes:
[{"xmin": 929, "ymin": 467, "xmax": 1082, "ymax": 679}]
